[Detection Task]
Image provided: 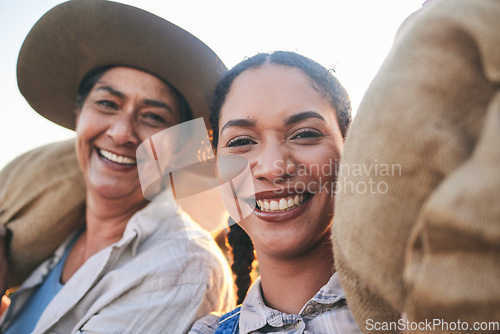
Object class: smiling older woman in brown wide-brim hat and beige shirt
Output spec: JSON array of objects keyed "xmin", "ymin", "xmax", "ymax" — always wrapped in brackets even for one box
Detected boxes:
[{"xmin": 0, "ymin": 0, "xmax": 232, "ymax": 333}]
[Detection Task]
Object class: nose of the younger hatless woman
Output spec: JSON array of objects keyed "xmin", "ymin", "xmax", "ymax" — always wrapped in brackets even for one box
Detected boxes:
[{"xmin": 251, "ymin": 143, "xmax": 296, "ymax": 184}]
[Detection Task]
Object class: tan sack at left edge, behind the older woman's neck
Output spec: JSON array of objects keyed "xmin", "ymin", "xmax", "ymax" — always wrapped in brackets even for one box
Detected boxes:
[{"xmin": 0, "ymin": 140, "xmax": 85, "ymax": 284}]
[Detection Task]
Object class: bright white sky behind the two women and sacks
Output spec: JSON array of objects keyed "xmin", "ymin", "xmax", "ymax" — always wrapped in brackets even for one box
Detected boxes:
[{"xmin": 0, "ymin": 0, "xmax": 424, "ymax": 168}]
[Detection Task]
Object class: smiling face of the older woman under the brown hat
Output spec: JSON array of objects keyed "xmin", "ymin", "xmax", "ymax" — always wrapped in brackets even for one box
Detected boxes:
[{"xmin": 76, "ymin": 67, "xmax": 180, "ymax": 201}]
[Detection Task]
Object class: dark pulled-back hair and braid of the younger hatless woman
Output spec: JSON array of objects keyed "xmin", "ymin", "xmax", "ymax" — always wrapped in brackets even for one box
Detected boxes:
[{"xmin": 210, "ymin": 51, "xmax": 352, "ymax": 304}]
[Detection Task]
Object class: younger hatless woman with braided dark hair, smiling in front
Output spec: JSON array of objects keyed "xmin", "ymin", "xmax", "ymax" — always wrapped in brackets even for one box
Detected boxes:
[{"xmin": 191, "ymin": 52, "xmax": 359, "ymax": 333}]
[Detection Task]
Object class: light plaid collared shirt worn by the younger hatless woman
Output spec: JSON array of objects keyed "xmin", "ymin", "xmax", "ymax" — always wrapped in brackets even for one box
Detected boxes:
[{"xmin": 189, "ymin": 274, "xmax": 361, "ymax": 334}]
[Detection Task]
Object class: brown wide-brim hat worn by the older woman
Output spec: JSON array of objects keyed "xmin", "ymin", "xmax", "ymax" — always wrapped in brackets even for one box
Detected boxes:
[{"xmin": 17, "ymin": 0, "xmax": 226, "ymax": 129}]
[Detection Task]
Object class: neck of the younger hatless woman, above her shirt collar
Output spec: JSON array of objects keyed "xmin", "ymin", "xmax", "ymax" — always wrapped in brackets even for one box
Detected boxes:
[{"xmin": 257, "ymin": 236, "xmax": 335, "ymax": 314}]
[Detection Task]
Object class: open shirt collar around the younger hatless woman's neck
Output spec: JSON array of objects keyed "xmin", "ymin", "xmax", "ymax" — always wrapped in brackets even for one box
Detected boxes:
[{"xmin": 239, "ymin": 273, "xmax": 345, "ymax": 334}]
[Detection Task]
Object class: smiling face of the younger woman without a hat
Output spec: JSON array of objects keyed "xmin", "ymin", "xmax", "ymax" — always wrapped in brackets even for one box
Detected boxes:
[{"xmin": 217, "ymin": 65, "xmax": 343, "ymax": 257}]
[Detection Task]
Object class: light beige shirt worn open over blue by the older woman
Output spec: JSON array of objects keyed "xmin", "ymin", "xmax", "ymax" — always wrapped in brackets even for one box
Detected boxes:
[{"xmin": 0, "ymin": 190, "xmax": 234, "ymax": 333}]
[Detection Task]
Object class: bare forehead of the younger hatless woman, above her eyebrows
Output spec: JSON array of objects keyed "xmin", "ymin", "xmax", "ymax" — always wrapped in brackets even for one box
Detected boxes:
[{"xmin": 219, "ymin": 64, "xmax": 336, "ymax": 125}]
